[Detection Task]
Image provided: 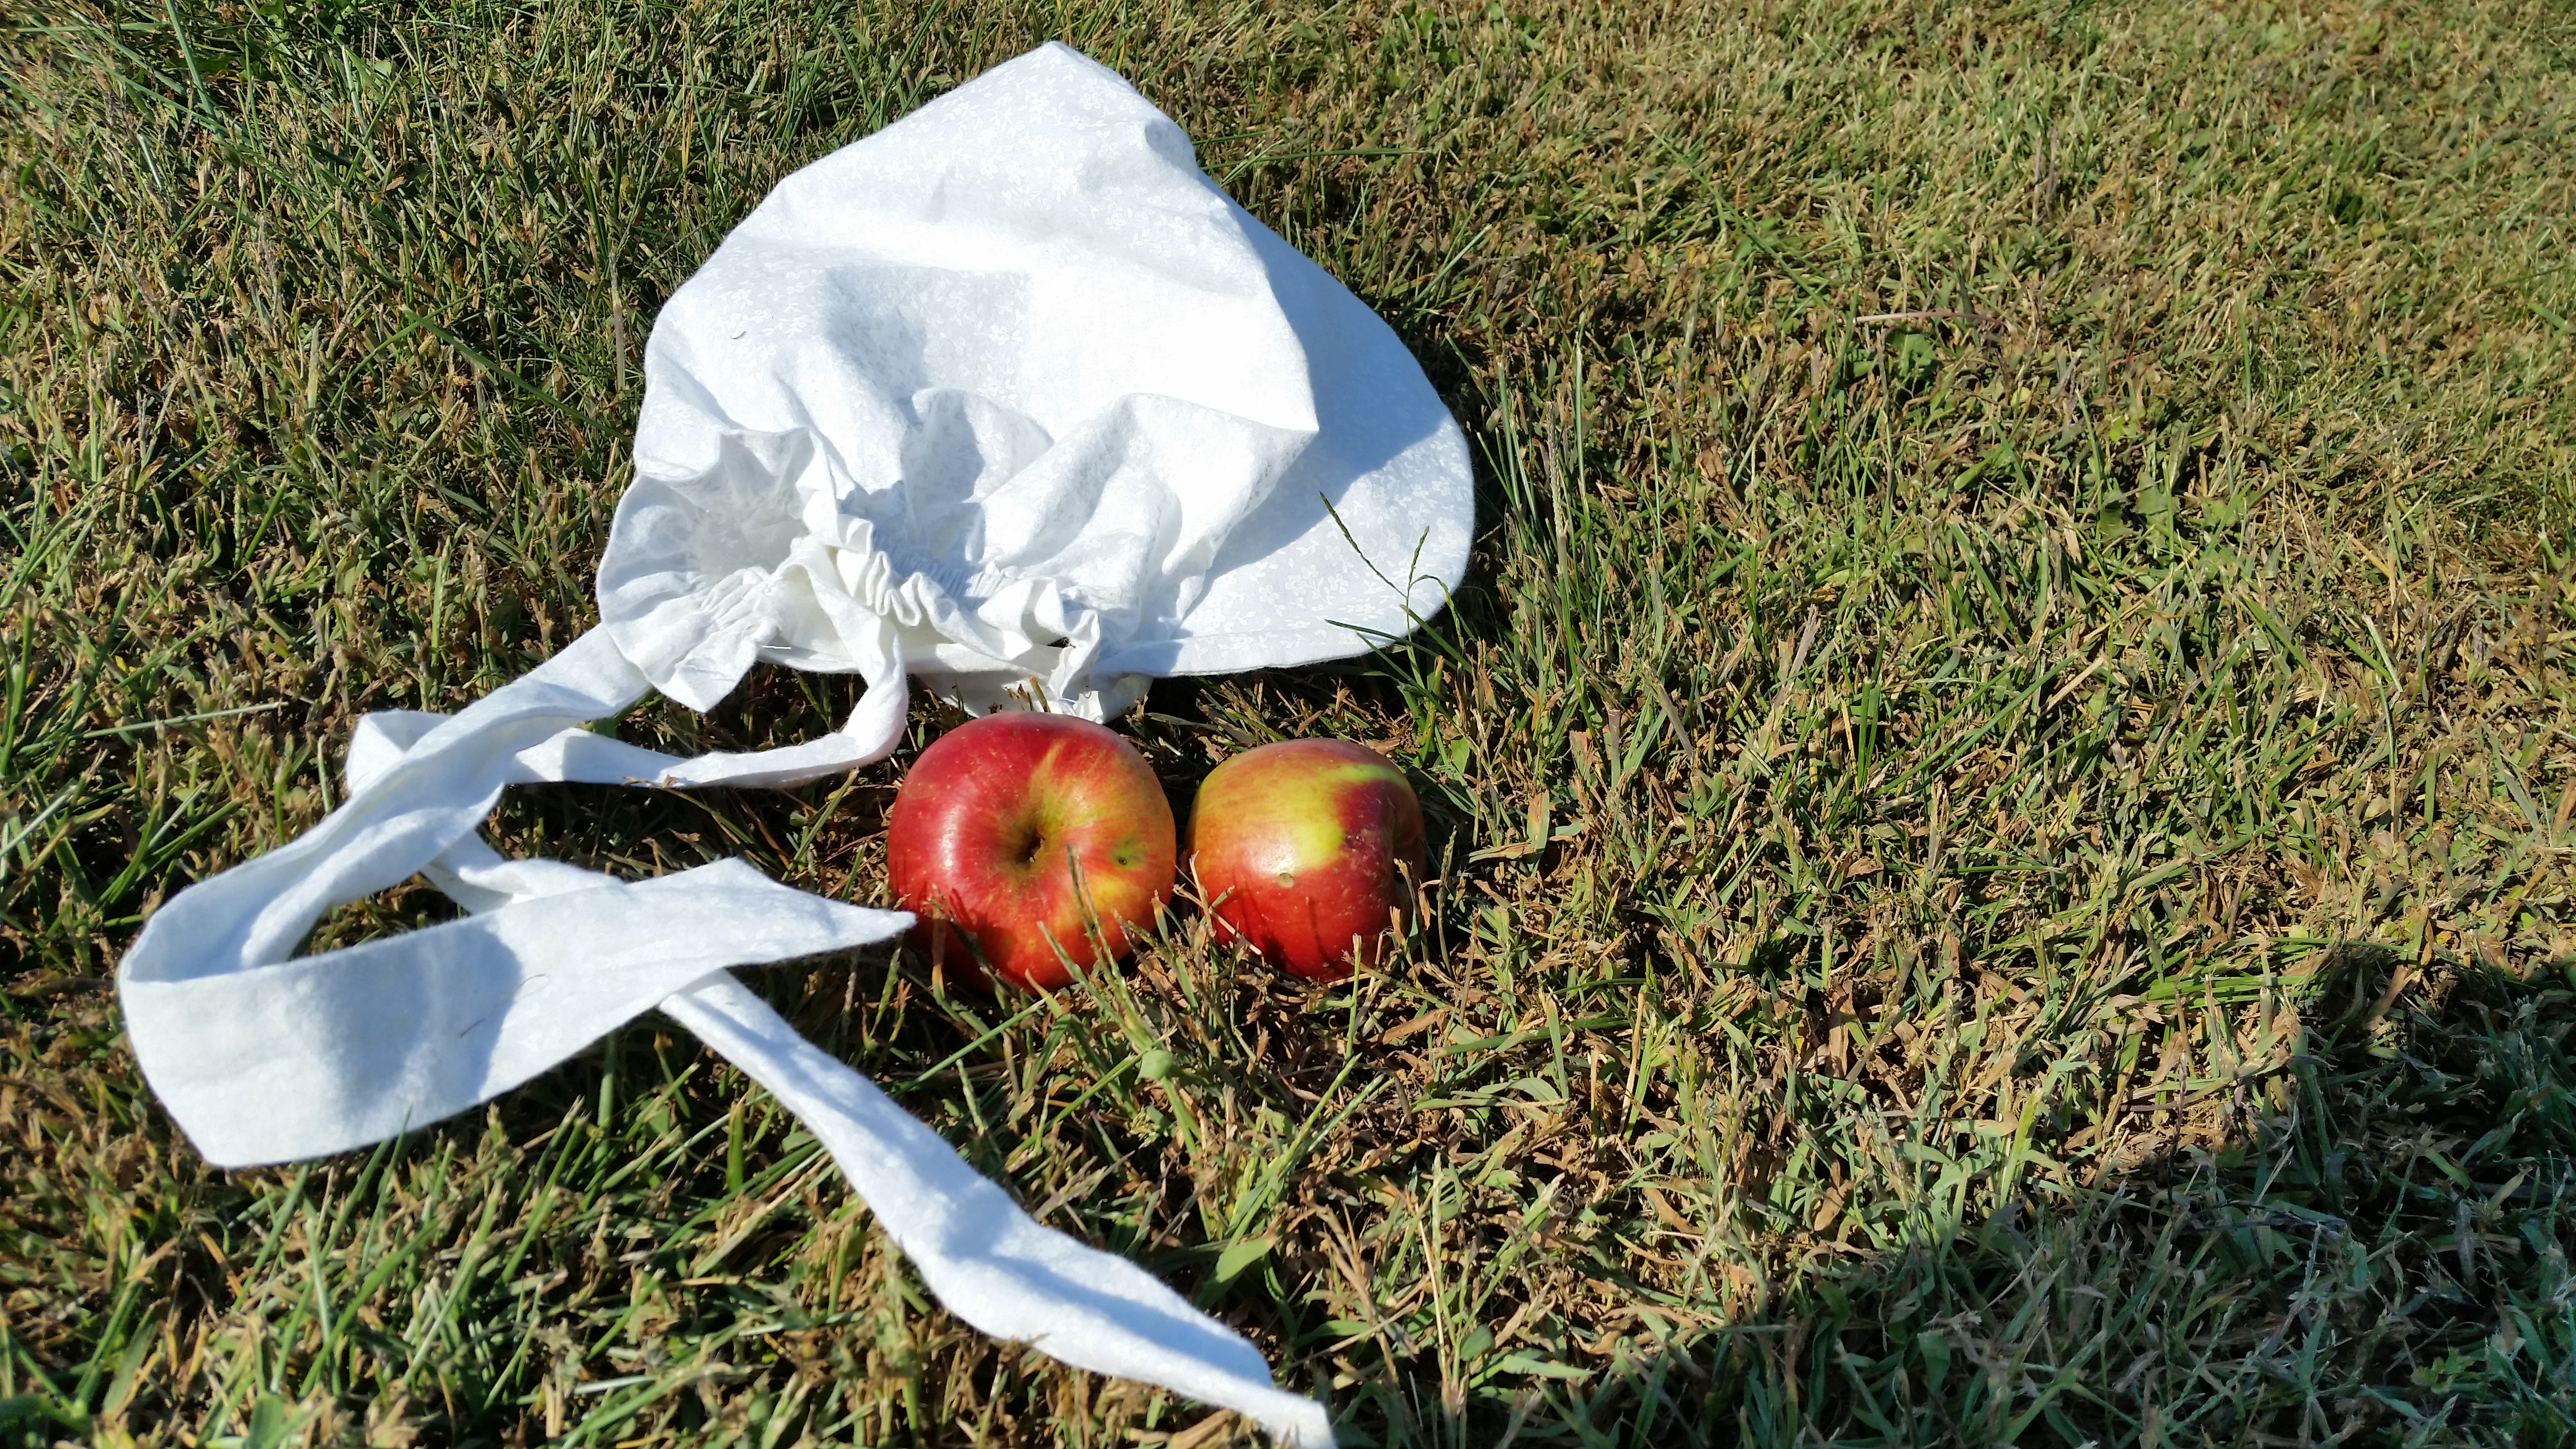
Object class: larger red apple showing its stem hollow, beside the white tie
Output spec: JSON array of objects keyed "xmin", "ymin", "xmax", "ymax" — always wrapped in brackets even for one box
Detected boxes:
[{"xmin": 886, "ymin": 711, "xmax": 1172, "ymax": 987}]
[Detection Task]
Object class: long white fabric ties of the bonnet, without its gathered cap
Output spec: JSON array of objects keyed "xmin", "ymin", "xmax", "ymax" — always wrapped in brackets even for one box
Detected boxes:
[{"xmin": 118, "ymin": 632, "xmax": 1332, "ymax": 1449}]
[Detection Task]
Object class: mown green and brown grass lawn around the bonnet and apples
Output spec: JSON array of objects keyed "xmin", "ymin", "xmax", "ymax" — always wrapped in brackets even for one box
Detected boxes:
[{"xmin": 0, "ymin": 0, "xmax": 2576, "ymax": 1449}]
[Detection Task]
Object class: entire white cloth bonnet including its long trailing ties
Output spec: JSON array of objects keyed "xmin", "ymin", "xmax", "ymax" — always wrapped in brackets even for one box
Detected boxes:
[{"xmin": 118, "ymin": 44, "xmax": 1473, "ymax": 1447}]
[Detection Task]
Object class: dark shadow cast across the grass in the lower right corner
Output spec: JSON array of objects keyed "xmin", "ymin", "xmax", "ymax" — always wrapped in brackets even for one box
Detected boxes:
[{"xmin": 1308, "ymin": 946, "xmax": 2576, "ymax": 1447}]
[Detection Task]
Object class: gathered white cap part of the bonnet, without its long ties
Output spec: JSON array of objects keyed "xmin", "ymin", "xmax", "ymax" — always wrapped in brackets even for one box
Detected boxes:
[{"xmin": 600, "ymin": 44, "xmax": 1473, "ymax": 742}]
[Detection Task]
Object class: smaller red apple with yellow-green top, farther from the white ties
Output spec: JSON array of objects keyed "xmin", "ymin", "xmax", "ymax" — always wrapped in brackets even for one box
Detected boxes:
[{"xmin": 1190, "ymin": 740, "xmax": 1425, "ymax": 982}]
